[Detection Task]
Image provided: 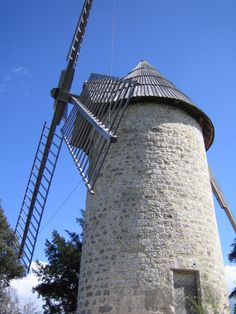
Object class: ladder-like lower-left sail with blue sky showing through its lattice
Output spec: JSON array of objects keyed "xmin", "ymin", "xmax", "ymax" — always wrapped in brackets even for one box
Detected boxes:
[{"xmin": 15, "ymin": 123, "xmax": 62, "ymax": 271}]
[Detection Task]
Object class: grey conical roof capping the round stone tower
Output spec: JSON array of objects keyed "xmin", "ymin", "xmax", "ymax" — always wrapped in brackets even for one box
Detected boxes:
[{"xmin": 124, "ymin": 61, "xmax": 214, "ymax": 149}]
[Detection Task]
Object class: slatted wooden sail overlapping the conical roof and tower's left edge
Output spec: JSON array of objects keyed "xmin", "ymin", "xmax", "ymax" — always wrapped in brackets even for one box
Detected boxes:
[{"xmin": 62, "ymin": 74, "xmax": 135, "ymax": 193}]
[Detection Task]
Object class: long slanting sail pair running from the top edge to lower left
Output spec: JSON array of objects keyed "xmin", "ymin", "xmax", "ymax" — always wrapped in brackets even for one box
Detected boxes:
[{"xmin": 15, "ymin": 0, "xmax": 92, "ymax": 271}]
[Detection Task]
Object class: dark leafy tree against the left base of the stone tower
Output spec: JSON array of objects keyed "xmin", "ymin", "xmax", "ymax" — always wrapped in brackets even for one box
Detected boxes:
[{"xmin": 33, "ymin": 230, "xmax": 82, "ymax": 314}]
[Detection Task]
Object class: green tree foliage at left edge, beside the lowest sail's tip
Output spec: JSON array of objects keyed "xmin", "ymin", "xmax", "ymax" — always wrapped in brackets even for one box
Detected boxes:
[{"xmin": 0, "ymin": 206, "xmax": 25, "ymax": 288}]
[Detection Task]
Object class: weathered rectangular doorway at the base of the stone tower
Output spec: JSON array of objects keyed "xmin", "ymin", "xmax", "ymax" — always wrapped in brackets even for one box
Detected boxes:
[{"xmin": 173, "ymin": 270, "xmax": 199, "ymax": 314}]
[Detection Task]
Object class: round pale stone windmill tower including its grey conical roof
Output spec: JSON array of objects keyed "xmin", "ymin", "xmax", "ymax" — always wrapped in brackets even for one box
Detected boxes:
[{"xmin": 77, "ymin": 61, "xmax": 228, "ymax": 314}]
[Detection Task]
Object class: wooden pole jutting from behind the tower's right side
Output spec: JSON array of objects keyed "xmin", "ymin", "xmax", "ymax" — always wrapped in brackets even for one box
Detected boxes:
[{"xmin": 209, "ymin": 169, "xmax": 236, "ymax": 232}]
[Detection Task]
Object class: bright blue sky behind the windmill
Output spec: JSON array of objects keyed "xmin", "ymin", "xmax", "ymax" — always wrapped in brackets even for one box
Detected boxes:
[{"xmin": 0, "ymin": 0, "xmax": 236, "ymax": 270}]
